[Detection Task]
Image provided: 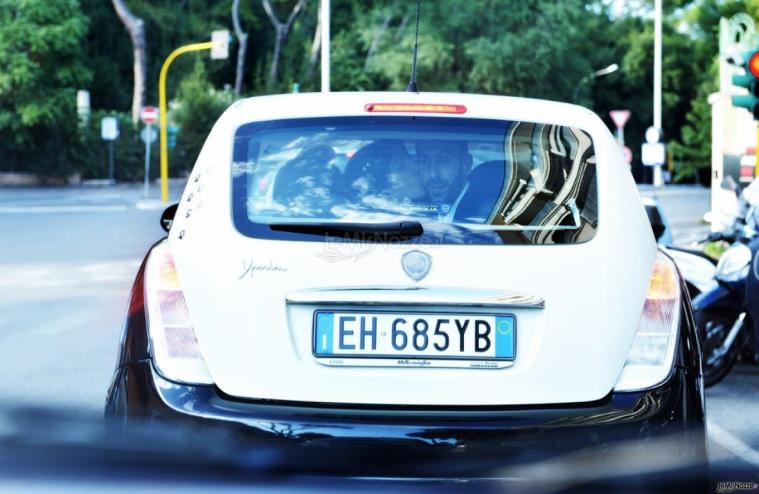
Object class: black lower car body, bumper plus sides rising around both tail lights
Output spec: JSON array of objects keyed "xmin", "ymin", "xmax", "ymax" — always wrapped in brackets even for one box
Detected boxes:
[{"xmin": 106, "ymin": 247, "xmax": 707, "ymax": 486}]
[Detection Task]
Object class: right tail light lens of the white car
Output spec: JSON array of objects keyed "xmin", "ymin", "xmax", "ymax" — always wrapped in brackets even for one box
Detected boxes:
[{"xmin": 614, "ymin": 252, "xmax": 680, "ymax": 391}]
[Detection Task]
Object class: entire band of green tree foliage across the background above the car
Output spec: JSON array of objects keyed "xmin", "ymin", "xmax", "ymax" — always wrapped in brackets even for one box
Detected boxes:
[{"xmin": 0, "ymin": 0, "xmax": 748, "ymax": 185}]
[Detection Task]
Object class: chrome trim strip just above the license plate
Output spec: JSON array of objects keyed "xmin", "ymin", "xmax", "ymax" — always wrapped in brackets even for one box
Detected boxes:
[{"xmin": 285, "ymin": 286, "xmax": 545, "ymax": 309}]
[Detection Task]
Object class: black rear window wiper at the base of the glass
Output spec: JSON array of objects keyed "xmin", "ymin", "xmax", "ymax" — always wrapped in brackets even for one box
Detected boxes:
[{"xmin": 269, "ymin": 221, "xmax": 424, "ymax": 242}]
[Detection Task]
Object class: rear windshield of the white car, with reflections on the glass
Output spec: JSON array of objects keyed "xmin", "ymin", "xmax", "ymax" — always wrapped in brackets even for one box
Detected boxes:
[{"xmin": 232, "ymin": 116, "xmax": 598, "ymax": 244}]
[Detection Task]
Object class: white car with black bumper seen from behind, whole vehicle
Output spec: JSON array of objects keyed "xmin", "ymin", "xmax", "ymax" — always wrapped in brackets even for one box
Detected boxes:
[{"xmin": 106, "ymin": 92, "xmax": 705, "ymax": 475}]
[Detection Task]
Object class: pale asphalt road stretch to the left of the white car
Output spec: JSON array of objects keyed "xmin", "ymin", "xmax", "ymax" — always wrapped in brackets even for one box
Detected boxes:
[{"xmin": 0, "ymin": 183, "xmax": 175, "ymax": 411}]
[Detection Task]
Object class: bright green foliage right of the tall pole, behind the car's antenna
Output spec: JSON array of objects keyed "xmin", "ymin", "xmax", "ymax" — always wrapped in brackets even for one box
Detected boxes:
[{"xmin": 332, "ymin": 0, "xmax": 608, "ymax": 100}]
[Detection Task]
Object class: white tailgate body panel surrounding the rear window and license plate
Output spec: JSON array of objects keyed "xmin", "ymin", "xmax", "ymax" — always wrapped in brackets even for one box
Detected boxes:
[{"xmin": 169, "ymin": 93, "xmax": 656, "ymax": 406}]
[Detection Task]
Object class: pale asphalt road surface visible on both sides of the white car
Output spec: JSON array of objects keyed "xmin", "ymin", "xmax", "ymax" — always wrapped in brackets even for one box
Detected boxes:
[{"xmin": 0, "ymin": 182, "xmax": 759, "ymax": 482}]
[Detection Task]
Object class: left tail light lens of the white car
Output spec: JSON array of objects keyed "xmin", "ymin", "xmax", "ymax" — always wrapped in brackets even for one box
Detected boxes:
[{"xmin": 145, "ymin": 243, "xmax": 213, "ymax": 384}]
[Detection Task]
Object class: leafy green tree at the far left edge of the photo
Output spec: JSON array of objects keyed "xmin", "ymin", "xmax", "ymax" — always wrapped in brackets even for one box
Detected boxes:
[{"xmin": 0, "ymin": 0, "xmax": 90, "ymax": 174}]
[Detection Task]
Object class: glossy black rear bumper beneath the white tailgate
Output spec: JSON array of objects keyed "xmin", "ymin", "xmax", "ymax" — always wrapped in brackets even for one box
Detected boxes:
[{"xmin": 107, "ymin": 360, "xmax": 705, "ymax": 480}]
